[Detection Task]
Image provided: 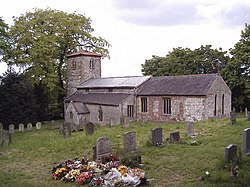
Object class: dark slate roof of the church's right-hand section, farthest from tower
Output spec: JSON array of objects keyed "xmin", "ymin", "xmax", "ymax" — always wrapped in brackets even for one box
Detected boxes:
[{"xmin": 137, "ymin": 74, "xmax": 217, "ymax": 96}]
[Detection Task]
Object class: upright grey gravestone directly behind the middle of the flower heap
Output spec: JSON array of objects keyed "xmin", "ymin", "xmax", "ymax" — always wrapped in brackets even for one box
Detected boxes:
[{"xmin": 96, "ymin": 136, "xmax": 111, "ymax": 160}]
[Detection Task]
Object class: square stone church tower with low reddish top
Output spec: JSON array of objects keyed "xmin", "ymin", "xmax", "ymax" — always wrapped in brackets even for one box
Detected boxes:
[{"xmin": 66, "ymin": 50, "xmax": 101, "ymax": 96}]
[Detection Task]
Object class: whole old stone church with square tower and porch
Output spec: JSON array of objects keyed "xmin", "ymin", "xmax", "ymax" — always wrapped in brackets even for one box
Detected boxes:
[{"xmin": 64, "ymin": 51, "xmax": 231, "ymax": 125}]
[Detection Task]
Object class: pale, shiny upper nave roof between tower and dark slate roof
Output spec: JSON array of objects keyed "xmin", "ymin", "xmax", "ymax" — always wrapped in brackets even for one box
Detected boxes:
[{"xmin": 77, "ymin": 76, "xmax": 150, "ymax": 89}]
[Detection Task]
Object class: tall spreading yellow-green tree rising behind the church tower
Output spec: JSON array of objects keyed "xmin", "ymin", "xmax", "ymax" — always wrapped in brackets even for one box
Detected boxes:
[{"xmin": 4, "ymin": 8, "xmax": 110, "ymax": 117}]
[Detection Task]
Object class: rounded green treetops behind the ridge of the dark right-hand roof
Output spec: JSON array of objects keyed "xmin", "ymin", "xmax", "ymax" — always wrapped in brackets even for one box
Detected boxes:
[{"xmin": 142, "ymin": 45, "xmax": 229, "ymax": 76}]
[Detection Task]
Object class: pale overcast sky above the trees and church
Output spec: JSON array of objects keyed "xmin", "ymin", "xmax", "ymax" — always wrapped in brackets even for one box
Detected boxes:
[{"xmin": 0, "ymin": 0, "xmax": 250, "ymax": 77}]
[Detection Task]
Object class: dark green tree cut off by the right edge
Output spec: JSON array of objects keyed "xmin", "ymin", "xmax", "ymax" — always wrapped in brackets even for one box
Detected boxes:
[{"xmin": 223, "ymin": 24, "xmax": 250, "ymax": 110}]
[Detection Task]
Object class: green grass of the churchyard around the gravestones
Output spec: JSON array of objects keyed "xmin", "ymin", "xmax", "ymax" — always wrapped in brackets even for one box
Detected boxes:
[{"xmin": 0, "ymin": 117, "xmax": 250, "ymax": 187}]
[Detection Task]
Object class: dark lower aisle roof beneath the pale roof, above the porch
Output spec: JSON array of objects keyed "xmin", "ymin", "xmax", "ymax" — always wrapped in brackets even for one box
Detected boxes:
[{"xmin": 65, "ymin": 91, "xmax": 131, "ymax": 106}]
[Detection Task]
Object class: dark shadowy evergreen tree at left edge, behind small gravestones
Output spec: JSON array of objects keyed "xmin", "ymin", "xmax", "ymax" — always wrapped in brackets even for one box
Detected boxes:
[{"xmin": 0, "ymin": 67, "xmax": 37, "ymax": 128}]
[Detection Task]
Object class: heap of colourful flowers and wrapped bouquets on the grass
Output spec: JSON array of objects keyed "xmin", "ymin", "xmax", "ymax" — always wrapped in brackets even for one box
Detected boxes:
[{"xmin": 52, "ymin": 157, "xmax": 148, "ymax": 187}]
